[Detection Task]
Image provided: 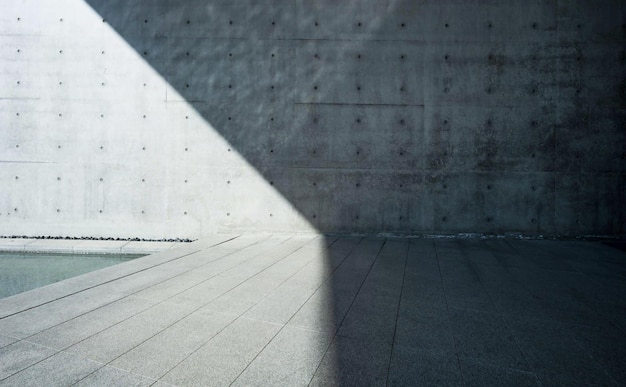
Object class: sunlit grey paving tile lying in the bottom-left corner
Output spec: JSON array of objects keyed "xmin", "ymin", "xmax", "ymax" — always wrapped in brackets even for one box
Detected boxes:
[{"xmin": 0, "ymin": 352, "xmax": 102, "ymax": 386}]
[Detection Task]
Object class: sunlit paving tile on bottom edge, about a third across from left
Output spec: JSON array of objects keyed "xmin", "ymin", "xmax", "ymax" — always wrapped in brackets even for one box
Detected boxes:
[{"xmin": 162, "ymin": 319, "xmax": 280, "ymax": 386}]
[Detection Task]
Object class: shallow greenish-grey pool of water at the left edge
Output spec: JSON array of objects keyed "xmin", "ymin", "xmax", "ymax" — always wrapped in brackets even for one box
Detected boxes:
[{"xmin": 0, "ymin": 252, "xmax": 143, "ymax": 298}]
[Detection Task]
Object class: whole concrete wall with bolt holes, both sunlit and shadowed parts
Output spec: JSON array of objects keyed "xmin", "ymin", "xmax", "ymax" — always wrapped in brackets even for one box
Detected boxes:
[{"xmin": 0, "ymin": 0, "xmax": 626, "ymax": 238}]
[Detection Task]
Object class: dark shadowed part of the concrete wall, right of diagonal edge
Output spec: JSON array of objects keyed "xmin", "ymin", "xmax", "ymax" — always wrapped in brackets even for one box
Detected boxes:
[{"xmin": 87, "ymin": 0, "xmax": 624, "ymax": 234}]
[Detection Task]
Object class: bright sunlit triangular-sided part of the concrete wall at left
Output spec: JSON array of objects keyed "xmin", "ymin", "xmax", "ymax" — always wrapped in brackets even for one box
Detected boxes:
[{"xmin": 0, "ymin": 0, "xmax": 316, "ymax": 238}]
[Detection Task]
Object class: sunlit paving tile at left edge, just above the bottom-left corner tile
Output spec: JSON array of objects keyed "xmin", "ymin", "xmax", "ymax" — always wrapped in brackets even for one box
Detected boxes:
[{"xmin": 0, "ymin": 341, "xmax": 57, "ymax": 380}]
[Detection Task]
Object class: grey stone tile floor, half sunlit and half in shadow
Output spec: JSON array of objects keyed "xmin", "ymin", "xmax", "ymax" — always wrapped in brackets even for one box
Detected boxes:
[{"xmin": 0, "ymin": 236, "xmax": 626, "ymax": 386}]
